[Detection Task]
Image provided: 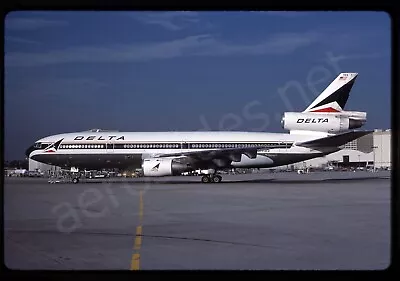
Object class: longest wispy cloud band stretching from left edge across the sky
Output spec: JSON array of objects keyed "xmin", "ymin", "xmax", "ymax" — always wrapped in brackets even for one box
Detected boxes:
[{"xmin": 5, "ymin": 32, "xmax": 320, "ymax": 66}]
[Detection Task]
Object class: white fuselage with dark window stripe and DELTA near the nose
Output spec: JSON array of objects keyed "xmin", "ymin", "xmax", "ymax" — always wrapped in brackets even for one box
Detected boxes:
[{"xmin": 27, "ymin": 131, "xmax": 336, "ymax": 169}]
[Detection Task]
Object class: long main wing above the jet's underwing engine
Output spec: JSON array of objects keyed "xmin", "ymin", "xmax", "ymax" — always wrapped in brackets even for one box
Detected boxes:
[{"xmin": 153, "ymin": 146, "xmax": 271, "ymax": 160}]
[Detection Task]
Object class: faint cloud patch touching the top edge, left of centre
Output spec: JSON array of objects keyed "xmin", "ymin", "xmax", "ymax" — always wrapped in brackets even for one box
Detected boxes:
[{"xmin": 132, "ymin": 11, "xmax": 199, "ymax": 31}]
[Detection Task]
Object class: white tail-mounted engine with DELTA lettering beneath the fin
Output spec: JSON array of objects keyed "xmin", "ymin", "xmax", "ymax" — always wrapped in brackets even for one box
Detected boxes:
[{"xmin": 281, "ymin": 111, "xmax": 366, "ymax": 133}]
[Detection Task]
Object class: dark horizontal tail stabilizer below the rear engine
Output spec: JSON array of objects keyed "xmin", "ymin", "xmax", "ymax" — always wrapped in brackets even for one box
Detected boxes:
[{"xmin": 296, "ymin": 131, "xmax": 373, "ymax": 148}]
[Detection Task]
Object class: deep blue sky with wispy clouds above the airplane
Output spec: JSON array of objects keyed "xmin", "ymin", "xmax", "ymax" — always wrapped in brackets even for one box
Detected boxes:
[{"xmin": 4, "ymin": 12, "xmax": 391, "ymax": 159}]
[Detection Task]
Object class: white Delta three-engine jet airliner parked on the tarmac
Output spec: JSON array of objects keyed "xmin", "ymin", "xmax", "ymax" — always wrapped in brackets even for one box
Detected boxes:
[{"xmin": 26, "ymin": 73, "xmax": 372, "ymax": 183}]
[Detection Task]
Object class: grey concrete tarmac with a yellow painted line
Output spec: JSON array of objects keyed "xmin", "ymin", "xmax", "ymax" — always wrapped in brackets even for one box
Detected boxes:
[{"xmin": 4, "ymin": 172, "xmax": 390, "ymax": 270}]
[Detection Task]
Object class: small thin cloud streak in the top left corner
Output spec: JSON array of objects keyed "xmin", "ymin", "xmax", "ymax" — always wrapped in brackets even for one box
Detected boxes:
[{"xmin": 5, "ymin": 18, "xmax": 69, "ymax": 30}]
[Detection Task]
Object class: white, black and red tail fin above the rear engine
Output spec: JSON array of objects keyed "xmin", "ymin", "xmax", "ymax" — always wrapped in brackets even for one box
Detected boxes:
[{"xmin": 303, "ymin": 73, "xmax": 358, "ymax": 112}]
